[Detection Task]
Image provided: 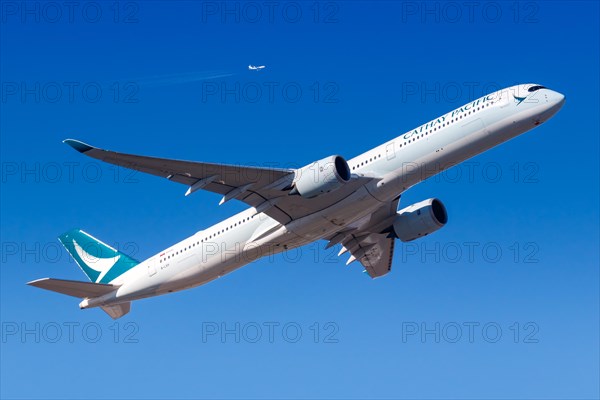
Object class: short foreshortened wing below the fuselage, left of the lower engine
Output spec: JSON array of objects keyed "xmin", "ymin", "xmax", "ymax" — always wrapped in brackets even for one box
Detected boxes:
[{"xmin": 328, "ymin": 198, "xmax": 399, "ymax": 278}]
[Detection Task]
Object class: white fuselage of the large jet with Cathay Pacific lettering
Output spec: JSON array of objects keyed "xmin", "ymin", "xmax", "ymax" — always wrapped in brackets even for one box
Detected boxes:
[{"xmin": 81, "ymin": 85, "xmax": 564, "ymax": 308}]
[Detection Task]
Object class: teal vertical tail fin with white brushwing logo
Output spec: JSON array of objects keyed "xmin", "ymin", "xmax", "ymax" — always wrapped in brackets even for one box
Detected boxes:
[{"xmin": 58, "ymin": 229, "xmax": 140, "ymax": 283}]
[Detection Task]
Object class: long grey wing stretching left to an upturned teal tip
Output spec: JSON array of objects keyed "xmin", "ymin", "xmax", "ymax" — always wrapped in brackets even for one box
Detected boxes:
[{"xmin": 64, "ymin": 139, "xmax": 370, "ymax": 224}]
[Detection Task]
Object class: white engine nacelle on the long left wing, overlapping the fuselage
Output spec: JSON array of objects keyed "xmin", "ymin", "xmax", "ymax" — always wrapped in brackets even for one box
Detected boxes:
[{"xmin": 292, "ymin": 156, "xmax": 351, "ymax": 198}]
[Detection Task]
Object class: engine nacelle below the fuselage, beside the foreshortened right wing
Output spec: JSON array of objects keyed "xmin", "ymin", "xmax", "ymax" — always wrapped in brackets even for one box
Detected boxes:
[{"xmin": 393, "ymin": 199, "xmax": 448, "ymax": 242}]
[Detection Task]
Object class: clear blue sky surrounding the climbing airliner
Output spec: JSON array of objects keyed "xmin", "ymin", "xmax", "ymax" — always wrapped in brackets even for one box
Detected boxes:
[{"xmin": 0, "ymin": 1, "xmax": 600, "ymax": 399}]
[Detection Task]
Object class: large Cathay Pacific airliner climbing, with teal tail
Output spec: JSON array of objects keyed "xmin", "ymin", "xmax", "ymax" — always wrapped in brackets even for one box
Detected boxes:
[{"xmin": 28, "ymin": 84, "xmax": 565, "ymax": 319}]
